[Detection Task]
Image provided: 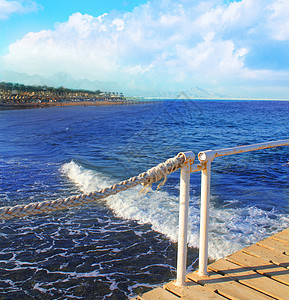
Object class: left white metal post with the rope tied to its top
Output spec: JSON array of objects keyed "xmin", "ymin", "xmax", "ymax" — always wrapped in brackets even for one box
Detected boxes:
[{"xmin": 175, "ymin": 152, "xmax": 195, "ymax": 286}]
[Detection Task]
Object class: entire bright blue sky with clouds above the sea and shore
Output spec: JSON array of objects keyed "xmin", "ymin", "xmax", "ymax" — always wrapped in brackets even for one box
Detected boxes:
[{"xmin": 0, "ymin": 0, "xmax": 289, "ymax": 99}]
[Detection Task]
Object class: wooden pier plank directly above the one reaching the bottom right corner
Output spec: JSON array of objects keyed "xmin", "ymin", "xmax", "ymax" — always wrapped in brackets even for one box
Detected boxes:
[{"xmin": 226, "ymin": 251, "xmax": 289, "ymax": 285}]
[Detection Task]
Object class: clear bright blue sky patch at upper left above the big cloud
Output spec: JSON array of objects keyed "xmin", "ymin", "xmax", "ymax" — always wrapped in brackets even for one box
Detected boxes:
[{"xmin": 0, "ymin": 0, "xmax": 146, "ymax": 54}]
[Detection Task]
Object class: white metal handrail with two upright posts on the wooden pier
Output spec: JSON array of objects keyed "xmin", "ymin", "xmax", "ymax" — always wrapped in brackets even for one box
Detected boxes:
[{"xmin": 175, "ymin": 139, "xmax": 289, "ymax": 286}]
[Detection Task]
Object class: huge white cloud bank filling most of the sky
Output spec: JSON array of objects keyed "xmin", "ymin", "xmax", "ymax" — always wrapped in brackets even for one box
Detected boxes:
[{"xmin": 0, "ymin": 0, "xmax": 289, "ymax": 96}]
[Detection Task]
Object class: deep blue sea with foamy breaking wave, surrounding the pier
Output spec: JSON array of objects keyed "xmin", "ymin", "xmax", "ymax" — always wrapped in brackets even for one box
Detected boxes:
[{"xmin": 0, "ymin": 100, "xmax": 289, "ymax": 299}]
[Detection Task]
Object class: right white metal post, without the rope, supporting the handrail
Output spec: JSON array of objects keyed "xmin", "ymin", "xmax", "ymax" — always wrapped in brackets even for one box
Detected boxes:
[{"xmin": 199, "ymin": 160, "xmax": 211, "ymax": 276}]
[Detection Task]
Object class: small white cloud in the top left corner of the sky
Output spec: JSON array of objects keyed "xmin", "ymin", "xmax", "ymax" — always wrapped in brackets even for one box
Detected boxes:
[{"xmin": 0, "ymin": 0, "xmax": 38, "ymax": 20}]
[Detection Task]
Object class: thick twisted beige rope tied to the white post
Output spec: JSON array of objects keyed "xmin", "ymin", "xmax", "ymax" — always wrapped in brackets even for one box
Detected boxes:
[{"xmin": 0, "ymin": 153, "xmax": 186, "ymax": 220}]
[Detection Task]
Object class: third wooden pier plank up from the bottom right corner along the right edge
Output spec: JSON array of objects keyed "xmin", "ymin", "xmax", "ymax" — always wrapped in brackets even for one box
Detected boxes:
[{"xmin": 242, "ymin": 245, "xmax": 289, "ymax": 268}]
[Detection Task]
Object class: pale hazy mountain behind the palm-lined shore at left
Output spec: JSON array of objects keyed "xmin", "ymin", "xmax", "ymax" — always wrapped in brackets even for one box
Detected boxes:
[{"xmin": 0, "ymin": 70, "xmax": 122, "ymax": 91}]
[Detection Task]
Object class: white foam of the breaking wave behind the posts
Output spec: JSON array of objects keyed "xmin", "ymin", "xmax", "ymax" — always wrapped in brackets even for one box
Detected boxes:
[{"xmin": 61, "ymin": 161, "xmax": 289, "ymax": 259}]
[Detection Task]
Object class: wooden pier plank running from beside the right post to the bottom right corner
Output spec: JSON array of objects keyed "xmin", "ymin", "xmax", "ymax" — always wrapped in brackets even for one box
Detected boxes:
[{"xmin": 209, "ymin": 259, "xmax": 289, "ymax": 300}]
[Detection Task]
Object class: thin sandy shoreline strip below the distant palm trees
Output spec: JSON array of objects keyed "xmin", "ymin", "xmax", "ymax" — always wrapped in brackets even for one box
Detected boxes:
[{"xmin": 0, "ymin": 100, "xmax": 148, "ymax": 110}]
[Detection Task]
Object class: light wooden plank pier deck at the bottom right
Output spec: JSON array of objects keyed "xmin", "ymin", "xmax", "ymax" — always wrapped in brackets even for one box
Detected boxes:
[{"xmin": 136, "ymin": 228, "xmax": 289, "ymax": 300}]
